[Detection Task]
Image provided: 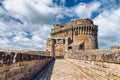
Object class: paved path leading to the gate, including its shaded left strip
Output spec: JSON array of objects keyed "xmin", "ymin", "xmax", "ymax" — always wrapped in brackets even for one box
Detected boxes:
[{"xmin": 33, "ymin": 59, "xmax": 88, "ymax": 80}]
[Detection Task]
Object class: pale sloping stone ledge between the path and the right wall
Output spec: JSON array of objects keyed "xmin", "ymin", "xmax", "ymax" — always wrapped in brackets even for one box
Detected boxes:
[{"xmin": 67, "ymin": 59, "xmax": 120, "ymax": 80}]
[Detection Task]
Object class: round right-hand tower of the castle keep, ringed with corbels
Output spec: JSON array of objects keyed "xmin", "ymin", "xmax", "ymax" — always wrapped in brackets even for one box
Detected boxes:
[{"xmin": 73, "ymin": 18, "xmax": 98, "ymax": 50}]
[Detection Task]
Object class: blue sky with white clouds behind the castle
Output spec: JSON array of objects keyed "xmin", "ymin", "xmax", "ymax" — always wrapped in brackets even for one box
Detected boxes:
[{"xmin": 0, "ymin": 0, "xmax": 120, "ymax": 50}]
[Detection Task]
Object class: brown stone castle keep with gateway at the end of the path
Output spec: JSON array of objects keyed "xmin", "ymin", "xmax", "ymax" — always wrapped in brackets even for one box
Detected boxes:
[{"xmin": 46, "ymin": 18, "xmax": 98, "ymax": 56}]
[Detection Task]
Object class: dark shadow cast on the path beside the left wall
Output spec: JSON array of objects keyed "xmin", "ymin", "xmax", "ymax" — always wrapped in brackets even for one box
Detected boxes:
[{"xmin": 31, "ymin": 60, "xmax": 55, "ymax": 80}]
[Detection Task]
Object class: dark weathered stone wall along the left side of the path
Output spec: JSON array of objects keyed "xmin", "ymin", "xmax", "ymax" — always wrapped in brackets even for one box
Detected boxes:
[{"xmin": 0, "ymin": 50, "xmax": 53, "ymax": 80}]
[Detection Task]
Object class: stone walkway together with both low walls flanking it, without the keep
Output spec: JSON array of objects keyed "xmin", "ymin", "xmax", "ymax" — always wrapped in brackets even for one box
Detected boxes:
[{"xmin": 0, "ymin": 50, "xmax": 120, "ymax": 80}]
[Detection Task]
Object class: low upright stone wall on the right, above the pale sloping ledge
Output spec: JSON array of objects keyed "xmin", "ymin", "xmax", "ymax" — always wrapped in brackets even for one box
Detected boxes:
[{"xmin": 68, "ymin": 49, "xmax": 120, "ymax": 63}]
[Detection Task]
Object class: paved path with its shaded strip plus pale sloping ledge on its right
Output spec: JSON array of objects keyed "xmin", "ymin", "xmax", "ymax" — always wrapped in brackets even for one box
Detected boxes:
[{"xmin": 33, "ymin": 59, "xmax": 120, "ymax": 80}]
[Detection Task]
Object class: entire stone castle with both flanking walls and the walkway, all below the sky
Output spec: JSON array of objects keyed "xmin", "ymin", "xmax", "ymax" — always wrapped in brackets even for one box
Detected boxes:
[{"xmin": 0, "ymin": 19, "xmax": 120, "ymax": 80}]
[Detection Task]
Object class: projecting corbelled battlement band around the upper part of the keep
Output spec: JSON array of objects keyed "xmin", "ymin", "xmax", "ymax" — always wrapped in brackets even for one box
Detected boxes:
[{"xmin": 51, "ymin": 24, "xmax": 98, "ymax": 35}]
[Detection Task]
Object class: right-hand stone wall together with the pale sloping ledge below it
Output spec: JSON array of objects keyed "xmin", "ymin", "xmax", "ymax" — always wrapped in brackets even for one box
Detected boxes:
[{"xmin": 68, "ymin": 49, "xmax": 120, "ymax": 80}]
